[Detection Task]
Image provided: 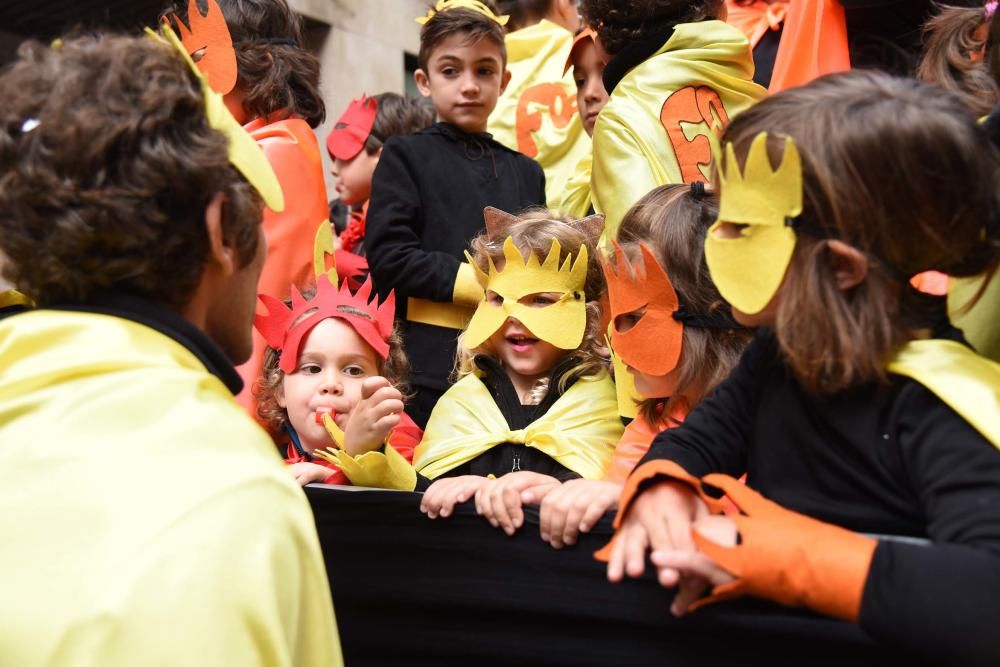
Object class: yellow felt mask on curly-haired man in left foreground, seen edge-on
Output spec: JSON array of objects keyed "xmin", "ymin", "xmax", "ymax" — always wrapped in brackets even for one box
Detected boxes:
[{"xmin": 146, "ymin": 23, "xmax": 285, "ymax": 213}]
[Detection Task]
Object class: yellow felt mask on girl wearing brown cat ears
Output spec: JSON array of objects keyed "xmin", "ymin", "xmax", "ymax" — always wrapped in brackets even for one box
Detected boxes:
[{"xmin": 465, "ymin": 236, "xmax": 588, "ymax": 350}]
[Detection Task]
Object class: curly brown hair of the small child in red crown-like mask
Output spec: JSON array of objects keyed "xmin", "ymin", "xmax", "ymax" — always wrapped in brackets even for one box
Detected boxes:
[{"xmin": 253, "ymin": 288, "xmax": 410, "ymax": 441}]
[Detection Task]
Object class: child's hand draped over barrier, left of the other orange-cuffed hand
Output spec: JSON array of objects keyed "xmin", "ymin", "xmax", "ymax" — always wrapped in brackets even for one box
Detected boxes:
[{"xmin": 608, "ymin": 482, "xmax": 708, "ymax": 588}]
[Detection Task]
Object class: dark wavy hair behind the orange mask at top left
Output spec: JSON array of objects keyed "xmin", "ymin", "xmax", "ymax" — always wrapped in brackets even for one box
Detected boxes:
[{"xmin": 162, "ymin": 0, "xmax": 326, "ymax": 128}]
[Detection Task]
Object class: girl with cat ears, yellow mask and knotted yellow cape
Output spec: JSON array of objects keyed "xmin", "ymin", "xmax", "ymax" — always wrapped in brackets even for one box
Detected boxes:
[{"xmin": 413, "ymin": 209, "xmax": 623, "ymax": 522}]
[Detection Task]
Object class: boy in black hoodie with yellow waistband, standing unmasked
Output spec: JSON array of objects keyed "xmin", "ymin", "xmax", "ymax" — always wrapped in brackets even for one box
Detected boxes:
[{"xmin": 366, "ymin": 0, "xmax": 545, "ymax": 427}]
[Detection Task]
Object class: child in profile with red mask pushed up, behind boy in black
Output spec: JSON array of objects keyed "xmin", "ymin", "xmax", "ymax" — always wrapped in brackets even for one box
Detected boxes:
[{"xmin": 326, "ymin": 93, "xmax": 434, "ymax": 281}]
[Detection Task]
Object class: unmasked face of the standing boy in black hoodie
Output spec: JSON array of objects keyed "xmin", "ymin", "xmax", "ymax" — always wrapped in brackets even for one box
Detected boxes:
[{"xmin": 414, "ymin": 33, "xmax": 510, "ymax": 133}]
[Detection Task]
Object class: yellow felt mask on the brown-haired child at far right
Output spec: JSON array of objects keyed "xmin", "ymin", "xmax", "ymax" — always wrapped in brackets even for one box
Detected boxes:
[{"xmin": 705, "ymin": 132, "xmax": 802, "ymax": 314}]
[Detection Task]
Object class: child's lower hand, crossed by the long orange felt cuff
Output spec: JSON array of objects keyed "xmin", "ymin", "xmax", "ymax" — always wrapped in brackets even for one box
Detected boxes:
[{"xmin": 649, "ymin": 515, "xmax": 739, "ymax": 616}]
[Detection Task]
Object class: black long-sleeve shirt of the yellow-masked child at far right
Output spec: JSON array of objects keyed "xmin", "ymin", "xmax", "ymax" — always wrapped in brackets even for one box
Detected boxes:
[{"xmin": 640, "ymin": 329, "xmax": 1000, "ymax": 664}]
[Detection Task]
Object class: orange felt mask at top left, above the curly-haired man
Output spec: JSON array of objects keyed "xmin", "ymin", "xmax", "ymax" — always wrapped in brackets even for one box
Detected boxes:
[{"xmin": 164, "ymin": 0, "xmax": 237, "ymax": 95}]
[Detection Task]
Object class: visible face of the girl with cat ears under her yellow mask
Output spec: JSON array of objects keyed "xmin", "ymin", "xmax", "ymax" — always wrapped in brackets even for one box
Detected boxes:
[{"xmin": 486, "ymin": 292, "xmax": 567, "ymax": 386}]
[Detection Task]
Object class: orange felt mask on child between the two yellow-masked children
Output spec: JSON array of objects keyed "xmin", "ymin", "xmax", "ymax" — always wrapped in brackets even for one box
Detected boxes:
[{"xmin": 602, "ymin": 241, "xmax": 684, "ymax": 375}]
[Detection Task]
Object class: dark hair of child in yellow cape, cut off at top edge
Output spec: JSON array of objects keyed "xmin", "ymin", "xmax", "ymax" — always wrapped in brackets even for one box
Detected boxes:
[{"xmin": 582, "ymin": 0, "xmax": 724, "ymax": 54}]
